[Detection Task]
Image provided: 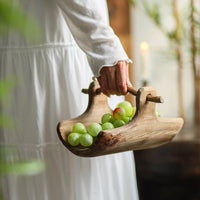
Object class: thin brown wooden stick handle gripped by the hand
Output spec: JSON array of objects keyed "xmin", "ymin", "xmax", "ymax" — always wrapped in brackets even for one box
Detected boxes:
[{"xmin": 82, "ymin": 86, "xmax": 164, "ymax": 103}]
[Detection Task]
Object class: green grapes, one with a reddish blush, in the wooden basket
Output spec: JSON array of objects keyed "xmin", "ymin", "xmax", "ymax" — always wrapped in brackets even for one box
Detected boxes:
[{"xmin": 68, "ymin": 101, "xmax": 160, "ymax": 147}]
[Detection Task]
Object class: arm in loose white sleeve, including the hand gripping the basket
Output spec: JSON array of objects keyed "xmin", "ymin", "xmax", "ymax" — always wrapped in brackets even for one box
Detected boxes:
[{"xmin": 57, "ymin": 0, "xmax": 130, "ymax": 95}]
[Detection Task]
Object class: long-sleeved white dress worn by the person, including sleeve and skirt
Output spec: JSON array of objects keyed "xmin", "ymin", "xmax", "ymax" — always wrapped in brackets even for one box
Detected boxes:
[{"xmin": 0, "ymin": 0, "xmax": 138, "ymax": 200}]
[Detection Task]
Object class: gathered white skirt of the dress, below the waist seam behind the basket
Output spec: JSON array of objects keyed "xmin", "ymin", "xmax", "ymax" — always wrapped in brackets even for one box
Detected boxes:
[{"xmin": 0, "ymin": 44, "xmax": 138, "ymax": 200}]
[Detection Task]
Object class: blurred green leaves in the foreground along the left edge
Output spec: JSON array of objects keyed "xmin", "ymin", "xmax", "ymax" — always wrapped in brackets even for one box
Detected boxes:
[{"xmin": 0, "ymin": 0, "xmax": 46, "ymax": 200}]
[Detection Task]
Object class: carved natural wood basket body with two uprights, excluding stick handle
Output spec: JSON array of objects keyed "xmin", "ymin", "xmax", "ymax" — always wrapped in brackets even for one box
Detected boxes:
[{"xmin": 57, "ymin": 81, "xmax": 183, "ymax": 157}]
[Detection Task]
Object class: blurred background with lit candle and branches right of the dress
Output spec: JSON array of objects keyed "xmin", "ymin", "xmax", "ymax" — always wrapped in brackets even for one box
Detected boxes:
[{"xmin": 108, "ymin": 0, "xmax": 200, "ymax": 200}]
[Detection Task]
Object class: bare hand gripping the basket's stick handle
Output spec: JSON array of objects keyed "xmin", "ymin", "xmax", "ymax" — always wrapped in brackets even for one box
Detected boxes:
[{"xmin": 97, "ymin": 61, "xmax": 131, "ymax": 97}]
